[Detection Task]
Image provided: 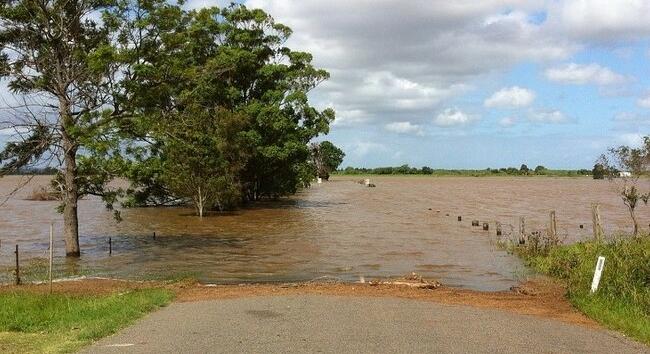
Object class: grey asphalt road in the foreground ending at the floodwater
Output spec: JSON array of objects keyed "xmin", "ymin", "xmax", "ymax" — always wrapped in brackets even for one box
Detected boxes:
[{"xmin": 86, "ymin": 295, "xmax": 650, "ymax": 353}]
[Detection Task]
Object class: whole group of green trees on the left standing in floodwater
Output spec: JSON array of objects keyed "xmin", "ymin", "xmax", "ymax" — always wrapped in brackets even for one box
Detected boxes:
[{"xmin": 0, "ymin": 0, "xmax": 334, "ymax": 256}]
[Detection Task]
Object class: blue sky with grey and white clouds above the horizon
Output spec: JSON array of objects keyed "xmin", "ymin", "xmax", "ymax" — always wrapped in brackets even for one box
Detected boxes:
[{"xmin": 2, "ymin": 0, "xmax": 650, "ymax": 168}]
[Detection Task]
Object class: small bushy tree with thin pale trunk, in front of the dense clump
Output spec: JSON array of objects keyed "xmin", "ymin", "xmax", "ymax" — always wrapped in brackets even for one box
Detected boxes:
[{"xmin": 160, "ymin": 108, "xmax": 247, "ymax": 217}]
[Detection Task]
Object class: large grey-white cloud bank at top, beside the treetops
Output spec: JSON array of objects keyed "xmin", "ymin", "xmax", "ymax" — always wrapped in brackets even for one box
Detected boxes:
[{"xmin": 247, "ymin": 0, "xmax": 578, "ymax": 126}]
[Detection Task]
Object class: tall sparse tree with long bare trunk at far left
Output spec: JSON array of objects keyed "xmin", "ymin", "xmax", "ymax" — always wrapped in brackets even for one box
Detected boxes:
[{"xmin": 0, "ymin": 0, "xmax": 120, "ymax": 256}]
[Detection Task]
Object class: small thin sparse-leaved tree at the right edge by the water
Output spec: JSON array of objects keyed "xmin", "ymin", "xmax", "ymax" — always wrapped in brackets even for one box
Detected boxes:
[{"xmin": 597, "ymin": 136, "xmax": 650, "ymax": 236}]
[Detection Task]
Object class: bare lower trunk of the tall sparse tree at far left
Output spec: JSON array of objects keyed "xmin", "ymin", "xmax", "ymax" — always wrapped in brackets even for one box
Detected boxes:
[{"xmin": 63, "ymin": 133, "xmax": 81, "ymax": 257}]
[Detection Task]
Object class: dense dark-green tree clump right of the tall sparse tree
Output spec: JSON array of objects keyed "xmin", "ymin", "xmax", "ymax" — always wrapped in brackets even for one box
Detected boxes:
[{"xmin": 117, "ymin": 2, "xmax": 334, "ymax": 209}]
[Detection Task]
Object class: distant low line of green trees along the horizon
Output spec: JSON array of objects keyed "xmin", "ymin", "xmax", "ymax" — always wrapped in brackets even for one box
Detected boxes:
[{"xmin": 336, "ymin": 164, "xmax": 592, "ymax": 177}]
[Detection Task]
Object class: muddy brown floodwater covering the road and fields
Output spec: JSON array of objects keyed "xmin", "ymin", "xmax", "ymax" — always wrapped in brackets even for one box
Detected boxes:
[{"xmin": 0, "ymin": 176, "xmax": 650, "ymax": 290}]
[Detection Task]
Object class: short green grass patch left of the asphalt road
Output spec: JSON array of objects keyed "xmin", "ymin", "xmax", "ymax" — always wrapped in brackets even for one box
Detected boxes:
[{"xmin": 0, "ymin": 289, "xmax": 173, "ymax": 353}]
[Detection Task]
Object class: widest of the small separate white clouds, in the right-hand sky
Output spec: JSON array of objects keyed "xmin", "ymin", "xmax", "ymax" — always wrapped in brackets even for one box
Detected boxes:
[{"xmin": 545, "ymin": 63, "xmax": 627, "ymax": 85}]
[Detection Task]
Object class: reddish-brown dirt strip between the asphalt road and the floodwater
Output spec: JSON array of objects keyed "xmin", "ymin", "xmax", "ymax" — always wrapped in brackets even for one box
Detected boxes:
[{"xmin": 0, "ymin": 278, "xmax": 598, "ymax": 327}]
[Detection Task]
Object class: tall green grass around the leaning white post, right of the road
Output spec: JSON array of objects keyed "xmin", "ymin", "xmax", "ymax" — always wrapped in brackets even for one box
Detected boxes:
[{"xmin": 516, "ymin": 236, "xmax": 650, "ymax": 345}]
